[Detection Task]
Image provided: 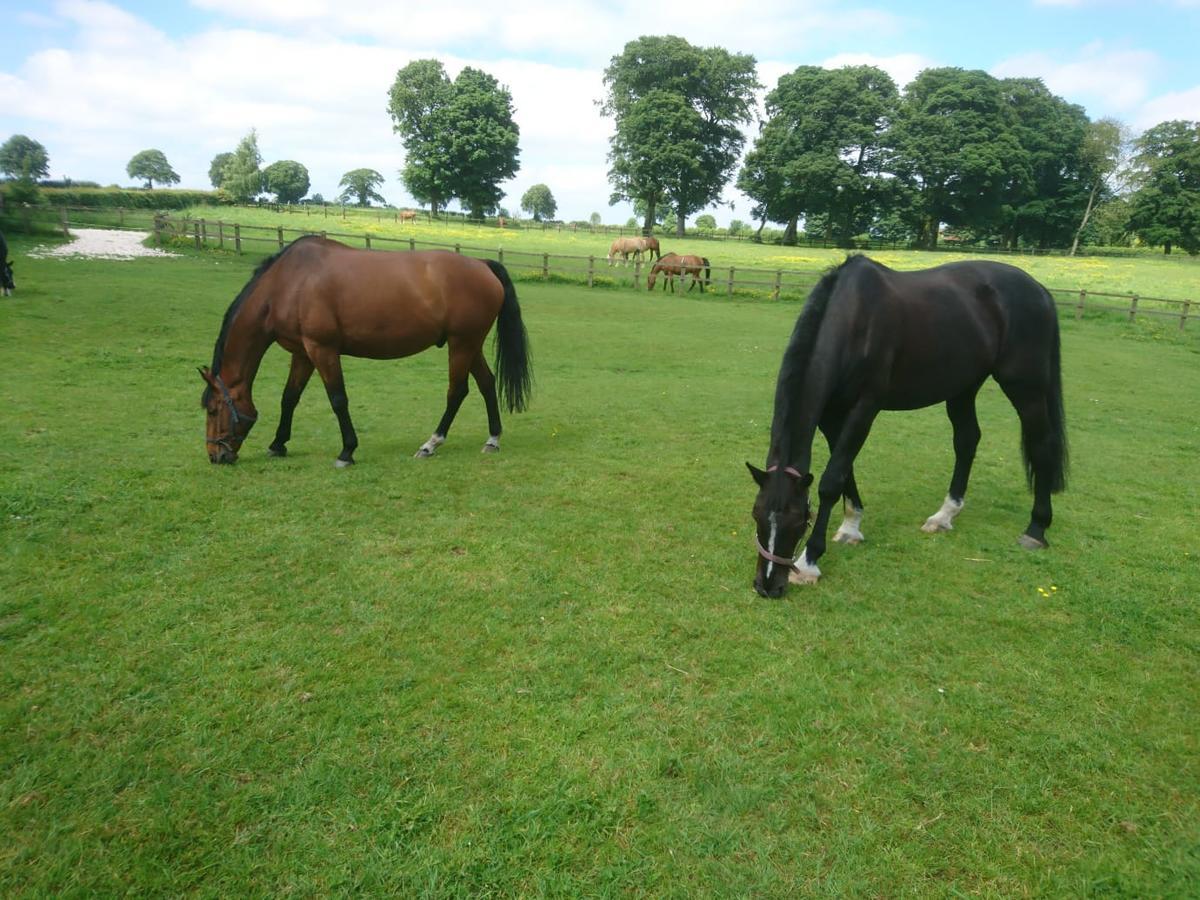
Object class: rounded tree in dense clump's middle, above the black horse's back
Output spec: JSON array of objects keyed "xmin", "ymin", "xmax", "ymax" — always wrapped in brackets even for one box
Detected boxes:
[{"xmin": 886, "ymin": 67, "xmax": 1032, "ymax": 247}]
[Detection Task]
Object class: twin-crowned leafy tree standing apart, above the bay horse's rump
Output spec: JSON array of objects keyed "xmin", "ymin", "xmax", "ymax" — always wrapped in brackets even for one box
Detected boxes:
[{"xmin": 388, "ymin": 59, "xmax": 521, "ymax": 216}]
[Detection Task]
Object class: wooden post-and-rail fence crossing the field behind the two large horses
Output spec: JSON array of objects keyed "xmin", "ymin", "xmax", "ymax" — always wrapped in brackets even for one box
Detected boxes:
[{"xmin": 5, "ymin": 208, "xmax": 1196, "ymax": 330}]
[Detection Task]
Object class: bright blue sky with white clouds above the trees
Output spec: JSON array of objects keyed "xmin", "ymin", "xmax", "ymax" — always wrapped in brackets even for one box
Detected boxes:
[{"xmin": 0, "ymin": 0, "xmax": 1200, "ymax": 223}]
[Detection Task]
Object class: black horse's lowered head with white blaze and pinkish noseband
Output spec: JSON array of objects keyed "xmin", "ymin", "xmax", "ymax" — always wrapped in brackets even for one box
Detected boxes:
[{"xmin": 746, "ymin": 463, "xmax": 812, "ymax": 598}]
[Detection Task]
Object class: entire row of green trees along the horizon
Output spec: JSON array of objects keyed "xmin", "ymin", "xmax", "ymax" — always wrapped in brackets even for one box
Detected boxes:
[{"xmin": 0, "ymin": 36, "xmax": 1200, "ymax": 253}]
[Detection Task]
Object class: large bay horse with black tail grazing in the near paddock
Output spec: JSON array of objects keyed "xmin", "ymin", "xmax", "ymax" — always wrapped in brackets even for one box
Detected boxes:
[{"xmin": 200, "ymin": 236, "xmax": 530, "ymax": 467}]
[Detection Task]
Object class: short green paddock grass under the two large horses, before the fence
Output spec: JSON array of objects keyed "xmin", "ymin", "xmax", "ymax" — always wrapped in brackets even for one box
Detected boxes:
[{"xmin": 0, "ymin": 240, "xmax": 1200, "ymax": 896}]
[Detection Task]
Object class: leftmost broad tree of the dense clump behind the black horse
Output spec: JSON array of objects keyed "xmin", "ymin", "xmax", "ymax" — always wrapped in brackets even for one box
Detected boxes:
[{"xmin": 738, "ymin": 66, "xmax": 898, "ymax": 242}]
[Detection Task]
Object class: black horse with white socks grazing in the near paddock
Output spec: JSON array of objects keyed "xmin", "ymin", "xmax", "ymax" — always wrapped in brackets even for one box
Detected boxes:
[{"xmin": 746, "ymin": 257, "xmax": 1067, "ymax": 596}]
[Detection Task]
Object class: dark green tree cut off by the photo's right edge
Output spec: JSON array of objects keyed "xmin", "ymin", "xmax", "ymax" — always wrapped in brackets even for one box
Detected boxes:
[{"xmin": 1129, "ymin": 120, "xmax": 1200, "ymax": 256}]
